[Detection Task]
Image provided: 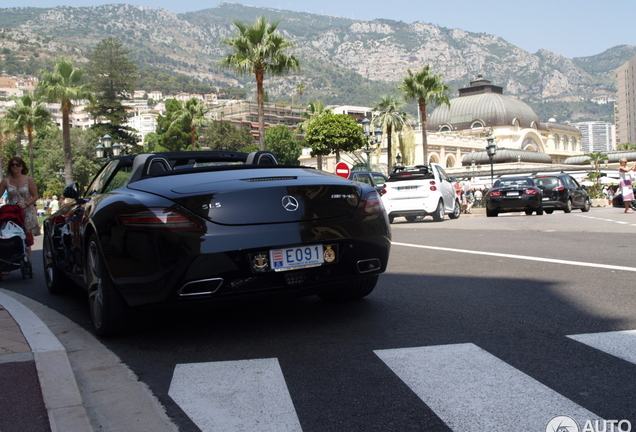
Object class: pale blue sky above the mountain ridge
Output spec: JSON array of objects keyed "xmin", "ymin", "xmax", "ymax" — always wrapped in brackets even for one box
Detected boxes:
[{"xmin": 9, "ymin": 0, "xmax": 636, "ymax": 58}]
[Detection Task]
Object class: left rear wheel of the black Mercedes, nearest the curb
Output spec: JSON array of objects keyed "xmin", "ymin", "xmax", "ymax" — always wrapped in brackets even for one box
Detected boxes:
[{"xmin": 86, "ymin": 234, "xmax": 132, "ymax": 336}]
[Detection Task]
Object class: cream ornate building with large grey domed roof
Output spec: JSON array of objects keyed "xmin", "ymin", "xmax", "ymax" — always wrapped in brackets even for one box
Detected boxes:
[{"xmin": 426, "ymin": 76, "xmax": 582, "ymax": 168}]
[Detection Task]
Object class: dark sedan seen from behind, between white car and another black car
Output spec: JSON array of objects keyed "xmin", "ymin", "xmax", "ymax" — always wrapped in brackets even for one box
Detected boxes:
[{"xmin": 486, "ymin": 177, "xmax": 543, "ymax": 217}]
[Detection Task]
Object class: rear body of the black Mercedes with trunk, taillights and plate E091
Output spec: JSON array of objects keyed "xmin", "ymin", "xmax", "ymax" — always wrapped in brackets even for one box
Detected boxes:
[{"xmin": 91, "ymin": 167, "xmax": 391, "ymax": 306}]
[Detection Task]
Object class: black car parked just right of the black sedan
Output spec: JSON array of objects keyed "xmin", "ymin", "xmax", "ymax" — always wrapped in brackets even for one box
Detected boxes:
[{"xmin": 534, "ymin": 174, "xmax": 592, "ymax": 214}]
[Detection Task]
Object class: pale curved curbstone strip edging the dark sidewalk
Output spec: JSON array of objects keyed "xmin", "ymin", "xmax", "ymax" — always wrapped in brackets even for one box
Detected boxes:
[{"xmin": 0, "ymin": 289, "xmax": 94, "ymax": 432}]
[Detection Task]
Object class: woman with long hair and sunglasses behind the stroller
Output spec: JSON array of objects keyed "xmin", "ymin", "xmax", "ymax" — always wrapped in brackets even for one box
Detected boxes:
[{"xmin": 0, "ymin": 156, "xmax": 40, "ymax": 258}]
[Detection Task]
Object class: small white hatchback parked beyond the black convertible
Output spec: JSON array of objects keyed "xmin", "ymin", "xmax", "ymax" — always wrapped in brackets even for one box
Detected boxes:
[{"xmin": 382, "ymin": 164, "xmax": 461, "ymax": 223}]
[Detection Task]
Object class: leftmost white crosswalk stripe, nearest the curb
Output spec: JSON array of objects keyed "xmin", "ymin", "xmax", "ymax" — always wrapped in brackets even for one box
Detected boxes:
[{"xmin": 168, "ymin": 359, "xmax": 302, "ymax": 432}]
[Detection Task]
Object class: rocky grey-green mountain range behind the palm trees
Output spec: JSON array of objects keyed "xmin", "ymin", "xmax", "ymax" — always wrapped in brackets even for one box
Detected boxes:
[{"xmin": 0, "ymin": 3, "xmax": 636, "ymax": 121}]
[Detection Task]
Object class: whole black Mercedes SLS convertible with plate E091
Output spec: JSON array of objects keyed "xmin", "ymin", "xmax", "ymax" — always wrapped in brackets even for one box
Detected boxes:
[{"xmin": 43, "ymin": 151, "xmax": 391, "ymax": 335}]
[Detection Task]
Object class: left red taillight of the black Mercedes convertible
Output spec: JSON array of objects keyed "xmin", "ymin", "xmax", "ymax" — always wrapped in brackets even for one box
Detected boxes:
[{"xmin": 117, "ymin": 208, "xmax": 201, "ymax": 231}]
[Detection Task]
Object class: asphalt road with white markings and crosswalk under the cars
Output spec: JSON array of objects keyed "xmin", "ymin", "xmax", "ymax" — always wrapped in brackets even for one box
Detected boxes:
[{"xmin": 3, "ymin": 208, "xmax": 636, "ymax": 432}]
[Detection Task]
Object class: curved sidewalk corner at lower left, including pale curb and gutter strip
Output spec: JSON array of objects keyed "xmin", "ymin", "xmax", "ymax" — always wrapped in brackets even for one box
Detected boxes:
[{"xmin": 0, "ymin": 288, "xmax": 178, "ymax": 432}]
